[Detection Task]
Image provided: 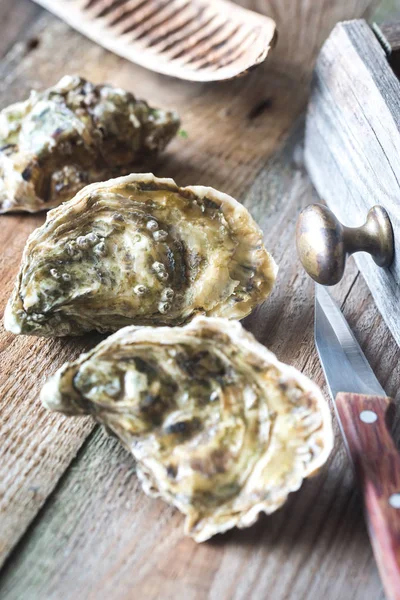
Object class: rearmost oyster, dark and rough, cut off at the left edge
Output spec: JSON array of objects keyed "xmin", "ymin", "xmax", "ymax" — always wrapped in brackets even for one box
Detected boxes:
[{"xmin": 0, "ymin": 76, "xmax": 179, "ymax": 213}]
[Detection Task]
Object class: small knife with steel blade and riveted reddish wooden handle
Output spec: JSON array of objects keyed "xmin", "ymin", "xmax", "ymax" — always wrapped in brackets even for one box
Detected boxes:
[{"xmin": 315, "ymin": 284, "xmax": 400, "ymax": 600}]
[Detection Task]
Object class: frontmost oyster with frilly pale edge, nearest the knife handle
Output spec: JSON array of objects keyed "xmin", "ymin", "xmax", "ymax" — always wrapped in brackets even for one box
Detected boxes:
[{"xmin": 41, "ymin": 317, "xmax": 333, "ymax": 542}]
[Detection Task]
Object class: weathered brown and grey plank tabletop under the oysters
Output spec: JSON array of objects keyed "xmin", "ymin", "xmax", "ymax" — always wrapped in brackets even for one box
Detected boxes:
[{"xmin": 0, "ymin": 0, "xmax": 400, "ymax": 600}]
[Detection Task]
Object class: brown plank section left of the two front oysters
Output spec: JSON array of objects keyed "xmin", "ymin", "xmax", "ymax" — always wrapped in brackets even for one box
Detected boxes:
[{"xmin": 0, "ymin": 216, "xmax": 93, "ymax": 559}]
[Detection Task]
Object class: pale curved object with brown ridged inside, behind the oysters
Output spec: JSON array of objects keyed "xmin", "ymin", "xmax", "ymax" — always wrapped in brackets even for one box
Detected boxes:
[{"xmin": 32, "ymin": 0, "xmax": 276, "ymax": 81}]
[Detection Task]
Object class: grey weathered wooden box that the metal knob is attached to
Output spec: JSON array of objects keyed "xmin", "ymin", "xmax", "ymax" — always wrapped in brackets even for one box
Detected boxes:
[{"xmin": 305, "ymin": 20, "xmax": 400, "ymax": 344}]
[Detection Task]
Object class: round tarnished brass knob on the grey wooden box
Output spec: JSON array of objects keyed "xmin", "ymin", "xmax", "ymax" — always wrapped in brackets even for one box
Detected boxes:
[{"xmin": 296, "ymin": 204, "xmax": 394, "ymax": 285}]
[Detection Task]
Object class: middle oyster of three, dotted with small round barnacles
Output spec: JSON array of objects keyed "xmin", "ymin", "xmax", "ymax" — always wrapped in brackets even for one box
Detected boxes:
[{"xmin": 5, "ymin": 174, "xmax": 276, "ymax": 336}]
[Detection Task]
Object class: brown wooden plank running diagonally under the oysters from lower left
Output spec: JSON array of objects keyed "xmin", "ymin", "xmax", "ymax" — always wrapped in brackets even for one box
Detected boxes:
[{"xmin": 0, "ymin": 5, "xmax": 320, "ymax": 560}]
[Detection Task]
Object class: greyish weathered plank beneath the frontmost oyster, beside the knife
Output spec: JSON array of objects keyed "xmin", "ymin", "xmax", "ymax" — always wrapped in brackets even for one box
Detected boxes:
[{"xmin": 0, "ymin": 123, "xmax": 400, "ymax": 600}]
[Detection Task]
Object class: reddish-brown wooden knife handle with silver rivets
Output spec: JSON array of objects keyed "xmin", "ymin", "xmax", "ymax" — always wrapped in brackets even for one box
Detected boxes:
[{"xmin": 336, "ymin": 392, "xmax": 400, "ymax": 600}]
